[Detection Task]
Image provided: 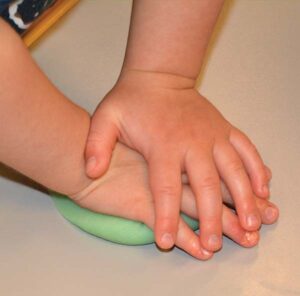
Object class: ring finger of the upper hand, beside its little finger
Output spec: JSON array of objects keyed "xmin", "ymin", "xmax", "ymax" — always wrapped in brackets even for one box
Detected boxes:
[{"xmin": 214, "ymin": 143, "xmax": 261, "ymax": 231}]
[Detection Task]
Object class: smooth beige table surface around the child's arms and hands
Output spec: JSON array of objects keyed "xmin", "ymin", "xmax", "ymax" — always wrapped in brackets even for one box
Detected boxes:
[{"xmin": 0, "ymin": 0, "xmax": 300, "ymax": 296}]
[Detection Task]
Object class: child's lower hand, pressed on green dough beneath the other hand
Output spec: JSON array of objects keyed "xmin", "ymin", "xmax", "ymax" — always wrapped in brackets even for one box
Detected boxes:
[{"xmin": 72, "ymin": 144, "xmax": 278, "ymax": 260}]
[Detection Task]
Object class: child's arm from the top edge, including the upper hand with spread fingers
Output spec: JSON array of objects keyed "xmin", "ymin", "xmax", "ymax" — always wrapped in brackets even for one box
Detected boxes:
[{"xmin": 86, "ymin": 0, "xmax": 268, "ymax": 250}]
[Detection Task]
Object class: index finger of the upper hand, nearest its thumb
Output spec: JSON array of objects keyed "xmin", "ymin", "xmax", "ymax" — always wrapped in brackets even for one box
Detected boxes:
[{"xmin": 148, "ymin": 149, "xmax": 182, "ymax": 249}]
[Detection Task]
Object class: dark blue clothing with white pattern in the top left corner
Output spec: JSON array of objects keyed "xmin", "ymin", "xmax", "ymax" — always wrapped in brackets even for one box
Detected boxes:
[{"xmin": 0, "ymin": 0, "xmax": 56, "ymax": 34}]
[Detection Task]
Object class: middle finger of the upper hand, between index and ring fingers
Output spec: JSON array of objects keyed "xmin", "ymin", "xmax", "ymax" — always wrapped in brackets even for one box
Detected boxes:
[{"xmin": 185, "ymin": 149, "xmax": 222, "ymax": 251}]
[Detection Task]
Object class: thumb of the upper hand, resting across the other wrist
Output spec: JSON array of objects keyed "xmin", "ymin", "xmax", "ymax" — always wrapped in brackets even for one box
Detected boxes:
[{"xmin": 85, "ymin": 114, "xmax": 118, "ymax": 179}]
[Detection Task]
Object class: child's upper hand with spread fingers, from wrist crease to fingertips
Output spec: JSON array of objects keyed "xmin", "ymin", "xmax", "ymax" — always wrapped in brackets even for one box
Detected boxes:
[{"xmin": 86, "ymin": 71, "xmax": 268, "ymax": 251}]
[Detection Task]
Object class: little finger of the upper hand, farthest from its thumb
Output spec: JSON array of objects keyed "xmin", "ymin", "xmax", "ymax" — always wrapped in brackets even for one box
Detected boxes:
[{"xmin": 229, "ymin": 128, "xmax": 270, "ymax": 198}]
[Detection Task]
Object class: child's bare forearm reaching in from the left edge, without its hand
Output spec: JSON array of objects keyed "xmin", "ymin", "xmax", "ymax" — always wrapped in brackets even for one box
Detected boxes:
[{"xmin": 0, "ymin": 19, "xmax": 90, "ymax": 194}]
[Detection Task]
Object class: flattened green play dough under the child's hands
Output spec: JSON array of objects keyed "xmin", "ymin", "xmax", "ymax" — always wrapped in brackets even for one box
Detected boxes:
[{"xmin": 50, "ymin": 192, "xmax": 198, "ymax": 245}]
